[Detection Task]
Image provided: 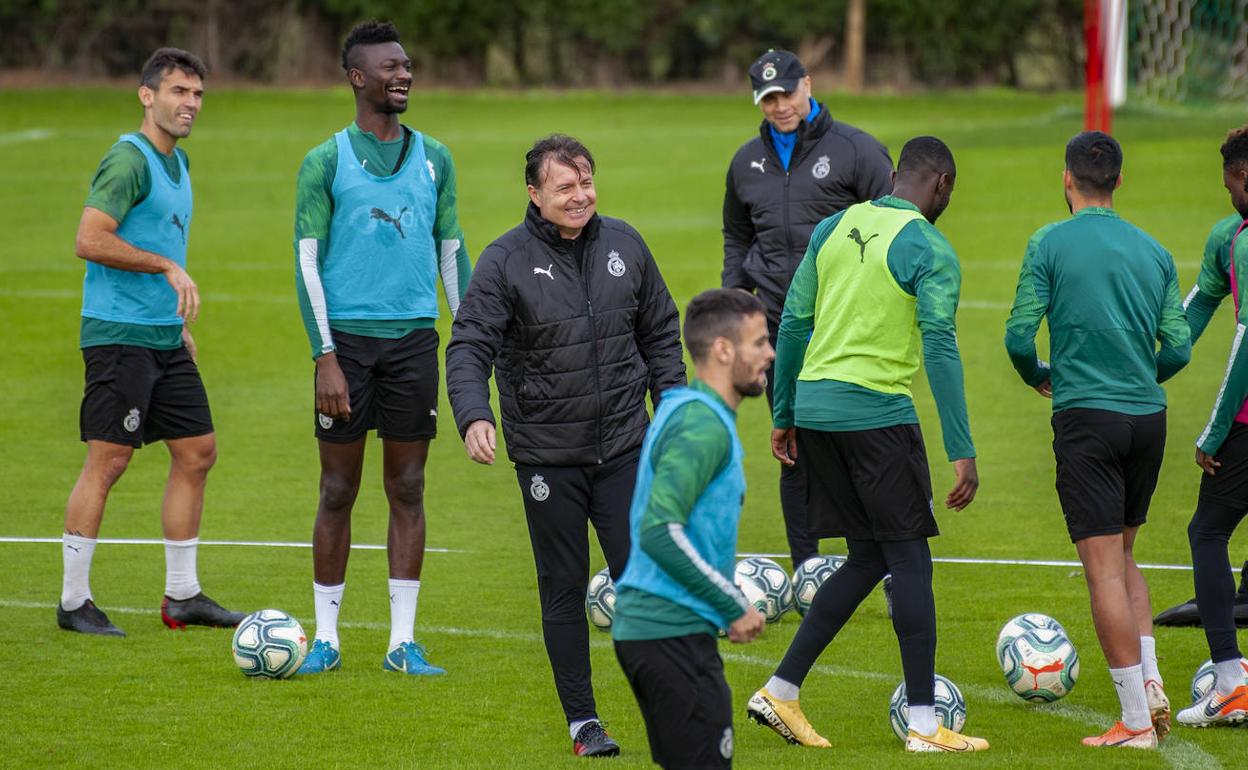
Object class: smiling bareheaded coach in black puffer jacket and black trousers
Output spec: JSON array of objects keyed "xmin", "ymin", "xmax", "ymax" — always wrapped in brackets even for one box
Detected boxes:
[{"xmin": 447, "ymin": 135, "xmax": 685, "ymax": 756}]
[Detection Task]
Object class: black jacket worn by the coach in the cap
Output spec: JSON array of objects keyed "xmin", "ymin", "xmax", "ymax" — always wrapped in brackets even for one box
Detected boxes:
[{"xmin": 721, "ymin": 105, "xmax": 892, "ymax": 322}]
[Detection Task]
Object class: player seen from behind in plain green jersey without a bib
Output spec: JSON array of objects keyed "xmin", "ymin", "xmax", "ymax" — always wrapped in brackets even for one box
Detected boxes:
[{"xmin": 1006, "ymin": 131, "xmax": 1192, "ymax": 749}]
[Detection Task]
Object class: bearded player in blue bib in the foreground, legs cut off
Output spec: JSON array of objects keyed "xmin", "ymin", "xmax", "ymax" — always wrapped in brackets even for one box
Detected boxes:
[{"xmin": 612, "ymin": 288, "xmax": 775, "ymax": 768}]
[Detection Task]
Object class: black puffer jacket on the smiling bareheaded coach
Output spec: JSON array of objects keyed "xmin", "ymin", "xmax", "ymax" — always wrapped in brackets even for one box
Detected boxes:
[{"xmin": 447, "ymin": 203, "xmax": 685, "ymax": 465}]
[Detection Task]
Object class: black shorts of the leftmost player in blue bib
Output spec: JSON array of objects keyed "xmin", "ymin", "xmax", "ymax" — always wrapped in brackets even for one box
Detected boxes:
[{"xmin": 79, "ymin": 344, "xmax": 212, "ymax": 448}]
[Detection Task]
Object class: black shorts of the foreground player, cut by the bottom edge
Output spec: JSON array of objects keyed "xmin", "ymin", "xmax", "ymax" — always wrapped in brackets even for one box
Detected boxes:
[{"xmin": 615, "ymin": 634, "xmax": 733, "ymax": 770}]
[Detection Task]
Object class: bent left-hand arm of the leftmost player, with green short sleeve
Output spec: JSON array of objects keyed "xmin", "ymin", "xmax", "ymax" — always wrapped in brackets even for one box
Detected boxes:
[{"xmin": 74, "ymin": 142, "xmax": 200, "ymax": 321}]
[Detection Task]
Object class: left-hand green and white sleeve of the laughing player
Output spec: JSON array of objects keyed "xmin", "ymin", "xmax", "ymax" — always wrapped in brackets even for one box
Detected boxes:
[{"xmin": 295, "ymin": 137, "xmax": 338, "ymax": 358}]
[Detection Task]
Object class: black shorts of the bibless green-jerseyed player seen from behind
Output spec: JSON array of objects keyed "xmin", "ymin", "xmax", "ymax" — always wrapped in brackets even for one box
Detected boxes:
[{"xmin": 1053, "ymin": 408, "xmax": 1166, "ymax": 543}]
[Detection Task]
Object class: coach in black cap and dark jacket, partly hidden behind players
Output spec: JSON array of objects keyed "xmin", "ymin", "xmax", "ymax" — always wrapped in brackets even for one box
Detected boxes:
[{"xmin": 723, "ymin": 51, "xmax": 892, "ymax": 568}]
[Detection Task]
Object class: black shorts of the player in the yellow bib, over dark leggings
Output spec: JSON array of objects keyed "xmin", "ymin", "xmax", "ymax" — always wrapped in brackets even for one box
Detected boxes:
[{"xmin": 797, "ymin": 424, "xmax": 940, "ymax": 540}]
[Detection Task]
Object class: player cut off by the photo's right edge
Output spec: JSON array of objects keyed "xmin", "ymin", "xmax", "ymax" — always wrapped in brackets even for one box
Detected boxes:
[{"xmin": 1178, "ymin": 126, "xmax": 1248, "ymax": 728}]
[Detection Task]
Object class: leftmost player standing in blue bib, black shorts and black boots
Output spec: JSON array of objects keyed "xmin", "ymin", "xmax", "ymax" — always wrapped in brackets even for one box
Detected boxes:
[{"xmin": 56, "ymin": 49, "xmax": 243, "ymax": 636}]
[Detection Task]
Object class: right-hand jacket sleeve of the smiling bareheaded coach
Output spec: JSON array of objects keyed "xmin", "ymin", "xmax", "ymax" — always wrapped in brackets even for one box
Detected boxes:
[{"xmin": 633, "ymin": 236, "xmax": 685, "ymax": 407}]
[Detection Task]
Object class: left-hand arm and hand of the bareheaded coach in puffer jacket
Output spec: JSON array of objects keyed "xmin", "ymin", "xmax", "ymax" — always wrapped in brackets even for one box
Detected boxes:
[{"xmin": 447, "ymin": 245, "xmax": 512, "ymax": 465}]
